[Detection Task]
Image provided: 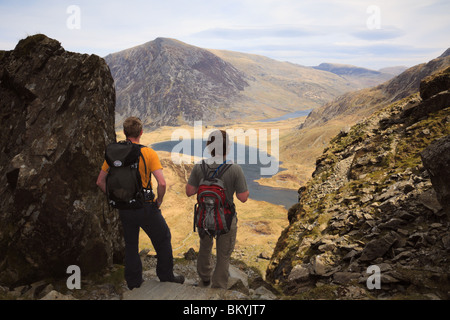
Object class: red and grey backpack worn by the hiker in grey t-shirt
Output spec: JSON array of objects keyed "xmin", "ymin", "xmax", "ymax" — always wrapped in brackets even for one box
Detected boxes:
[{"xmin": 194, "ymin": 161, "xmax": 236, "ymax": 238}]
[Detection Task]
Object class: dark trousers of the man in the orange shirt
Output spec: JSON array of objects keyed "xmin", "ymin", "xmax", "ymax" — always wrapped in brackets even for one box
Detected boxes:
[{"xmin": 119, "ymin": 203, "xmax": 174, "ymax": 288}]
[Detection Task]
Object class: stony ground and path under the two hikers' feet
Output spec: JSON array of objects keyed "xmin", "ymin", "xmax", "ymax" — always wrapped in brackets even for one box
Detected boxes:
[{"xmin": 0, "ymin": 250, "xmax": 278, "ymax": 300}]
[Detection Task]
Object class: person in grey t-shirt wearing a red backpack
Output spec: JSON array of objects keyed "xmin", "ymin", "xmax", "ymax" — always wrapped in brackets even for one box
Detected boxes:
[{"xmin": 186, "ymin": 130, "xmax": 249, "ymax": 289}]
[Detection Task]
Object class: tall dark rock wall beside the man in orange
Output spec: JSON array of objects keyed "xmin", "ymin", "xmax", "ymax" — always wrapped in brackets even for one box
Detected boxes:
[{"xmin": 0, "ymin": 35, "xmax": 123, "ymax": 285}]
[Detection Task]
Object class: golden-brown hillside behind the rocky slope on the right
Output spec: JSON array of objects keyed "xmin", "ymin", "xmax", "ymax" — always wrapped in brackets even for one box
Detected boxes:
[{"xmin": 280, "ymin": 50, "xmax": 450, "ymax": 182}]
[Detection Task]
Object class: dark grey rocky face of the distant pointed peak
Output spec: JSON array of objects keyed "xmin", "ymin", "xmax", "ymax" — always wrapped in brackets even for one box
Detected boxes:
[{"xmin": 105, "ymin": 38, "xmax": 248, "ymax": 127}]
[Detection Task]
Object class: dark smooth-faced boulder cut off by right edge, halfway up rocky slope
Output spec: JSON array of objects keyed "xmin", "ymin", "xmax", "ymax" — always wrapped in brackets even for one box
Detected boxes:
[{"xmin": 421, "ymin": 135, "xmax": 450, "ymax": 217}]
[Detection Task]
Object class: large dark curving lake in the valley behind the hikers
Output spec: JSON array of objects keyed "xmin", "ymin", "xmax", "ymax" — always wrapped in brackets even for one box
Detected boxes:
[{"xmin": 151, "ymin": 139, "xmax": 298, "ymax": 209}]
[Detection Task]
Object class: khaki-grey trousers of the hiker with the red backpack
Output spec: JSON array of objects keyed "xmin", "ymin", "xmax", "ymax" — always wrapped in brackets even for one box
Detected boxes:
[{"xmin": 197, "ymin": 216, "xmax": 237, "ymax": 289}]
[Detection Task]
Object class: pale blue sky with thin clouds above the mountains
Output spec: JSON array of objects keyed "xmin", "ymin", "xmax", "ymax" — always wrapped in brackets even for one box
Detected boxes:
[{"xmin": 0, "ymin": 0, "xmax": 450, "ymax": 70}]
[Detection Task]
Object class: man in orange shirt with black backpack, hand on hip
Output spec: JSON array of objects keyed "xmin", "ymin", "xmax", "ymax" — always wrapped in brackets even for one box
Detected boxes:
[{"xmin": 97, "ymin": 117, "xmax": 184, "ymax": 290}]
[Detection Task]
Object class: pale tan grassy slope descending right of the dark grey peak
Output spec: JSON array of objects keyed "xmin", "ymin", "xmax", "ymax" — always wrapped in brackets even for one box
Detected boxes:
[{"xmin": 209, "ymin": 50, "xmax": 357, "ymax": 119}]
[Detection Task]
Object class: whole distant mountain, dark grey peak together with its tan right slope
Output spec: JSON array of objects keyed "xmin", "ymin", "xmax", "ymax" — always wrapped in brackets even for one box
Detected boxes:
[{"xmin": 105, "ymin": 38, "xmax": 398, "ymax": 128}]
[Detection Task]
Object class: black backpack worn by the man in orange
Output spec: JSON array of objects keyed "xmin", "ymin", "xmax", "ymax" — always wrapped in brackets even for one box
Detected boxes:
[{"xmin": 105, "ymin": 141, "xmax": 154, "ymax": 209}]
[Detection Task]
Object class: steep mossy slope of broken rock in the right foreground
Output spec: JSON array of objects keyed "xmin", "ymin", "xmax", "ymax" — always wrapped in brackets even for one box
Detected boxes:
[{"xmin": 267, "ymin": 69, "xmax": 450, "ymax": 299}]
